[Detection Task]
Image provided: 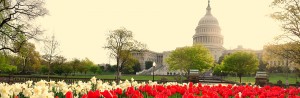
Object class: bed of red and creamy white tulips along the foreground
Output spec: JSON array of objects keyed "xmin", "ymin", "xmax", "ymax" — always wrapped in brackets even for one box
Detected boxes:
[{"xmin": 0, "ymin": 77, "xmax": 300, "ymax": 98}]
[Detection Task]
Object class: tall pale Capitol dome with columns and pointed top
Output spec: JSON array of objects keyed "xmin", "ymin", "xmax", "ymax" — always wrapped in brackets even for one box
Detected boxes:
[{"xmin": 193, "ymin": 0, "xmax": 224, "ymax": 62}]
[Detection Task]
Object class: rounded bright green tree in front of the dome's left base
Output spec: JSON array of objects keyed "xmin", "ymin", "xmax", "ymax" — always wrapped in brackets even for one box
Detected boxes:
[{"xmin": 166, "ymin": 44, "xmax": 214, "ymax": 75}]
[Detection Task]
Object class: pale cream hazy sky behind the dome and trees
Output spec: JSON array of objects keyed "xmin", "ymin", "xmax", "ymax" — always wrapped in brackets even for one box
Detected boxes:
[{"xmin": 38, "ymin": 0, "xmax": 282, "ymax": 63}]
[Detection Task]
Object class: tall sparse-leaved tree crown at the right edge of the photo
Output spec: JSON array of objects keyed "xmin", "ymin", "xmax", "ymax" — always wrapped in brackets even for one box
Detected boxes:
[{"xmin": 268, "ymin": 0, "xmax": 300, "ymax": 66}]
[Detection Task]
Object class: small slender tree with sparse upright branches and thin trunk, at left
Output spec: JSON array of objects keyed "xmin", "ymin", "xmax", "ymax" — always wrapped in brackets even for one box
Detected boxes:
[{"xmin": 43, "ymin": 35, "xmax": 59, "ymax": 79}]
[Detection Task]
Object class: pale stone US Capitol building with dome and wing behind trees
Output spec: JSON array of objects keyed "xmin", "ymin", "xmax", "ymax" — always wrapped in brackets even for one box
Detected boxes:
[{"xmin": 132, "ymin": 1, "xmax": 262, "ymax": 75}]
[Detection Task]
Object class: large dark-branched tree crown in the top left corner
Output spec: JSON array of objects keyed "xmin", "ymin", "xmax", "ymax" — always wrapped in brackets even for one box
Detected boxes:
[{"xmin": 0, "ymin": 0, "xmax": 48, "ymax": 53}]
